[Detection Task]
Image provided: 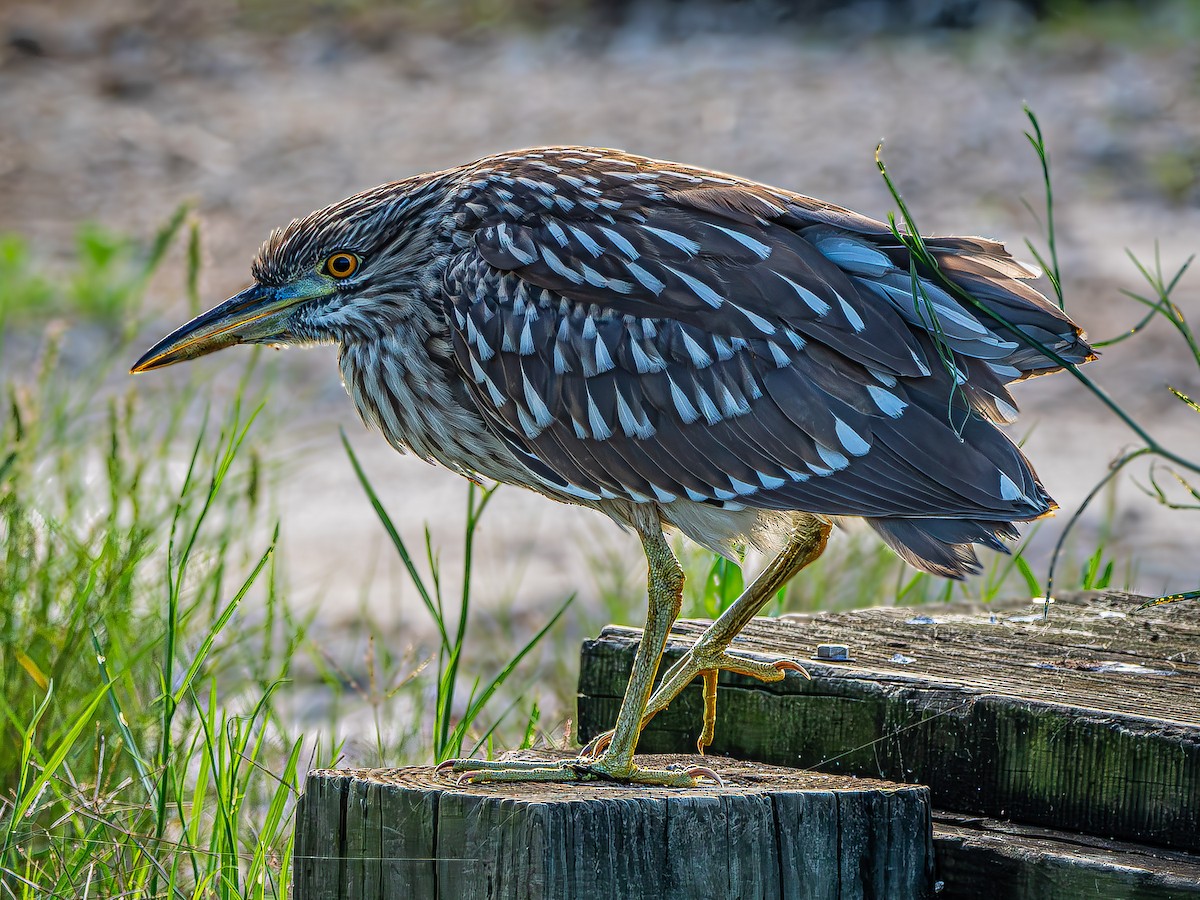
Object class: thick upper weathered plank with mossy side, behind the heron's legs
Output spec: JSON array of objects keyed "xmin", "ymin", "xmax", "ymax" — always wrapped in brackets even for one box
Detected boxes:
[{"xmin": 578, "ymin": 594, "xmax": 1200, "ymax": 852}]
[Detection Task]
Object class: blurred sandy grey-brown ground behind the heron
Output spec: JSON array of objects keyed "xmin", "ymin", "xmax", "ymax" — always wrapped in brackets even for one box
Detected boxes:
[{"xmin": 0, "ymin": 0, "xmax": 1200, "ymax": 633}]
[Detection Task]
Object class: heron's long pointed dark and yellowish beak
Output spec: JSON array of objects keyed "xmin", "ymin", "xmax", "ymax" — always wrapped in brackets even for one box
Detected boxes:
[{"xmin": 130, "ymin": 280, "xmax": 325, "ymax": 374}]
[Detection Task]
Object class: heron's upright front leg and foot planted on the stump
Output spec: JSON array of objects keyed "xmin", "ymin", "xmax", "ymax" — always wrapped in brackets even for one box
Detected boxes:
[{"xmin": 436, "ymin": 514, "xmax": 720, "ymax": 787}]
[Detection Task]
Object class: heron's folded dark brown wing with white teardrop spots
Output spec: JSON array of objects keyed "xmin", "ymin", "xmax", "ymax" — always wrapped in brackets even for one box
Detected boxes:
[{"xmin": 444, "ymin": 151, "xmax": 1060, "ymax": 521}]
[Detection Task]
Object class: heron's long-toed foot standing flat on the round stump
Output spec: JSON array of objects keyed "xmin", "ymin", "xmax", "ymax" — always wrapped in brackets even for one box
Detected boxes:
[{"xmin": 433, "ymin": 756, "xmax": 724, "ymax": 787}]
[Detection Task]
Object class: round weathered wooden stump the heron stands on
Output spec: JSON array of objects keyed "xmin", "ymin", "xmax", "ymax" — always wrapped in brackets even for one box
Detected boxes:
[{"xmin": 294, "ymin": 754, "xmax": 932, "ymax": 900}]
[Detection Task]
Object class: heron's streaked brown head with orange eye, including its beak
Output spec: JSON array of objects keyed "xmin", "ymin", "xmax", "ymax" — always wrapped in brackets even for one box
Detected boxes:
[{"xmin": 130, "ymin": 179, "xmax": 444, "ymax": 373}]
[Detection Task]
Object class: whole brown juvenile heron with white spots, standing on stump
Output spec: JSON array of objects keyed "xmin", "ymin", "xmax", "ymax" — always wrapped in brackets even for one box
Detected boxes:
[{"xmin": 133, "ymin": 146, "xmax": 1093, "ymax": 785}]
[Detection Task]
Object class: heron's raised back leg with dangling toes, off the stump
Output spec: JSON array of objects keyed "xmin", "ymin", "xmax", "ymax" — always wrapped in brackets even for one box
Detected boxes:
[{"xmin": 583, "ymin": 516, "xmax": 830, "ymax": 756}]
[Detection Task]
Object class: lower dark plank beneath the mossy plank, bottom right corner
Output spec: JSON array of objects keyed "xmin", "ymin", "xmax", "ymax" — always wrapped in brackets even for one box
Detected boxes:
[{"xmin": 934, "ymin": 812, "xmax": 1200, "ymax": 900}]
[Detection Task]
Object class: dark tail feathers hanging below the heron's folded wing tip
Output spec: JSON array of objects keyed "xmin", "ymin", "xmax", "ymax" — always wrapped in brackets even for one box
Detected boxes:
[{"xmin": 866, "ymin": 518, "xmax": 1018, "ymax": 580}]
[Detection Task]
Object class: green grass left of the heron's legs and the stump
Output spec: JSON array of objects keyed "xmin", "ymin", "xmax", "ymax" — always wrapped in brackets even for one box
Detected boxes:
[{"xmin": 0, "ymin": 210, "xmax": 570, "ymax": 900}]
